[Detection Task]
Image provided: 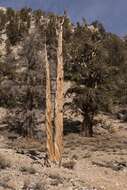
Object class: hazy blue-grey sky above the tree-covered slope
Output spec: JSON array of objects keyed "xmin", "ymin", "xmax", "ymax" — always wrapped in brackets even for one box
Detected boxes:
[{"xmin": 0, "ymin": 0, "xmax": 127, "ymax": 36}]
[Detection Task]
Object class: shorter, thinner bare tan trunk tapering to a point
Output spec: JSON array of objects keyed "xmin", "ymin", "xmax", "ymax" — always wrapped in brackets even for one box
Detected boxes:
[{"xmin": 44, "ymin": 44, "xmax": 54, "ymax": 161}]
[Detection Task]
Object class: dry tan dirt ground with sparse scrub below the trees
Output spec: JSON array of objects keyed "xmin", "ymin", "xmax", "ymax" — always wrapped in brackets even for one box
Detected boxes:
[{"xmin": 0, "ymin": 111, "xmax": 127, "ymax": 190}]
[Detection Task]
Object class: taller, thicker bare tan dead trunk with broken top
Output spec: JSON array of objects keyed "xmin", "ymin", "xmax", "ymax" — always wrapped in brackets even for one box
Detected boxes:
[{"xmin": 55, "ymin": 18, "xmax": 64, "ymax": 162}]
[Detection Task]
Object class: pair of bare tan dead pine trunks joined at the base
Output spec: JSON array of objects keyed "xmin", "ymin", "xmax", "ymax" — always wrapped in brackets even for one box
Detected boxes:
[{"xmin": 45, "ymin": 18, "xmax": 64, "ymax": 163}]
